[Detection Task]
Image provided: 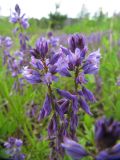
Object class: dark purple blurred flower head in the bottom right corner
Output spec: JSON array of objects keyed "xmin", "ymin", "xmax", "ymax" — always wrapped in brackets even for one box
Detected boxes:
[{"xmin": 95, "ymin": 117, "xmax": 120, "ymax": 151}]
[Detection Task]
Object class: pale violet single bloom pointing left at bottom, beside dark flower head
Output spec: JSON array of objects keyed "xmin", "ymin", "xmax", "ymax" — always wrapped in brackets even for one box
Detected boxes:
[{"xmin": 62, "ymin": 137, "xmax": 88, "ymax": 160}]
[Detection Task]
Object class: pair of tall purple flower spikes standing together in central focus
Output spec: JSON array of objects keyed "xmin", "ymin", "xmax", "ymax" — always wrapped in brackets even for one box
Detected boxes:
[{"xmin": 22, "ymin": 34, "xmax": 101, "ymax": 158}]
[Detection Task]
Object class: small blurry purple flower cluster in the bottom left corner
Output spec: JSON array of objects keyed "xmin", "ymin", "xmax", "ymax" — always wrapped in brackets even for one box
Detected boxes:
[{"xmin": 4, "ymin": 137, "xmax": 25, "ymax": 160}]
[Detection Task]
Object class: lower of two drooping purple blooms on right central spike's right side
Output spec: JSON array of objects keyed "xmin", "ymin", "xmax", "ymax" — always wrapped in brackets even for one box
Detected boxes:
[{"xmin": 79, "ymin": 98, "xmax": 92, "ymax": 115}]
